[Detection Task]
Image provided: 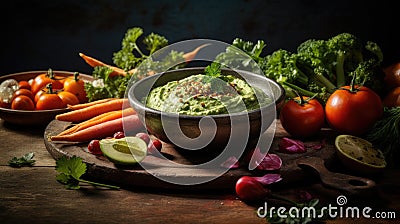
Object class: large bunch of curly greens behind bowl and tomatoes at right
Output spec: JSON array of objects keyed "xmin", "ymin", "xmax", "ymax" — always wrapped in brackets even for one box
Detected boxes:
[{"xmin": 216, "ymin": 33, "xmax": 384, "ymax": 102}]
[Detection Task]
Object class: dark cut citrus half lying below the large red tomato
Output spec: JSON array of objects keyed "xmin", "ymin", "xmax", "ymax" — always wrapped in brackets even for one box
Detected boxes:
[{"xmin": 335, "ymin": 135, "xmax": 386, "ymax": 174}]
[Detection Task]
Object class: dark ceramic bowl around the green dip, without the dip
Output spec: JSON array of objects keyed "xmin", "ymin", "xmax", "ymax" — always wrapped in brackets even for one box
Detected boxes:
[{"xmin": 128, "ymin": 67, "xmax": 285, "ymax": 151}]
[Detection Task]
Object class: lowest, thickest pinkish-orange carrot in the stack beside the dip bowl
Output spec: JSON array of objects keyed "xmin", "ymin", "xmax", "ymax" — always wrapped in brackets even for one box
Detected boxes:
[{"xmin": 50, "ymin": 115, "xmax": 144, "ymax": 142}]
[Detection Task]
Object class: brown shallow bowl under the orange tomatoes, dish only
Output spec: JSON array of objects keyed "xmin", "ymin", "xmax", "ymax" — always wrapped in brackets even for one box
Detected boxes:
[{"xmin": 0, "ymin": 71, "xmax": 93, "ymax": 126}]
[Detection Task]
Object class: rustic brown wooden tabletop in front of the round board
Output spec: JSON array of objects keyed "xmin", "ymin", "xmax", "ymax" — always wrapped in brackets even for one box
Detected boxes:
[{"xmin": 0, "ymin": 119, "xmax": 400, "ymax": 223}]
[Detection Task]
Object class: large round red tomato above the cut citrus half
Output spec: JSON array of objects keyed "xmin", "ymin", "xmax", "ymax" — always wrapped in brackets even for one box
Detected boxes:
[{"xmin": 325, "ymin": 86, "xmax": 383, "ymax": 135}]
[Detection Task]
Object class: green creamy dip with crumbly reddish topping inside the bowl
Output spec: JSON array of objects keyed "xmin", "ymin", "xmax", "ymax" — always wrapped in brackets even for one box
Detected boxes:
[{"xmin": 145, "ymin": 74, "xmax": 271, "ymax": 115}]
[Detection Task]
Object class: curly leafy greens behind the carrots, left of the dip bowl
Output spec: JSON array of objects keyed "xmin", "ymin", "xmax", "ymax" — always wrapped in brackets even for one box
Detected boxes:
[{"xmin": 85, "ymin": 27, "xmax": 184, "ymax": 101}]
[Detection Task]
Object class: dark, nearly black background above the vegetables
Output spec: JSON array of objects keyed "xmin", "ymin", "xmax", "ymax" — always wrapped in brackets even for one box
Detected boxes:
[{"xmin": 0, "ymin": 0, "xmax": 400, "ymax": 75}]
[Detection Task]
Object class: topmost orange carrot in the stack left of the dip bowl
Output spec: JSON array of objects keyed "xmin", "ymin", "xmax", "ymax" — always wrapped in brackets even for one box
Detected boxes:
[{"xmin": 56, "ymin": 98, "xmax": 128, "ymax": 122}]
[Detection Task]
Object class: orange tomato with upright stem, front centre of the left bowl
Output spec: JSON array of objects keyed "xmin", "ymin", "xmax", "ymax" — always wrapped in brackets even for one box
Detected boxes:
[{"xmin": 36, "ymin": 83, "xmax": 67, "ymax": 110}]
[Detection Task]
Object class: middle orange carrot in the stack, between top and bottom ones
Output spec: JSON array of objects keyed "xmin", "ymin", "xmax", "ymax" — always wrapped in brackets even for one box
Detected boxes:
[{"xmin": 58, "ymin": 108, "xmax": 136, "ymax": 135}]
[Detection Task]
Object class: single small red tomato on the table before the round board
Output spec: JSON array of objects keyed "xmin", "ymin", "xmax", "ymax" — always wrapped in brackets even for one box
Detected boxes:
[{"xmin": 235, "ymin": 176, "xmax": 270, "ymax": 201}]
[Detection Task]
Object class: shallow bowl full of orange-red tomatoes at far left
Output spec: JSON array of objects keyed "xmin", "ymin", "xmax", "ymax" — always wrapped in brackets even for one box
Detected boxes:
[{"xmin": 0, "ymin": 69, "xmax": 93, "ymax": 125}]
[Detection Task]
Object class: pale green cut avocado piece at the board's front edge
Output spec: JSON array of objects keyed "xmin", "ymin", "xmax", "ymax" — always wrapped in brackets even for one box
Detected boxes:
[{"xmin": 100, "ymin": 137, "xmax": 147, "ymax": 165}]
